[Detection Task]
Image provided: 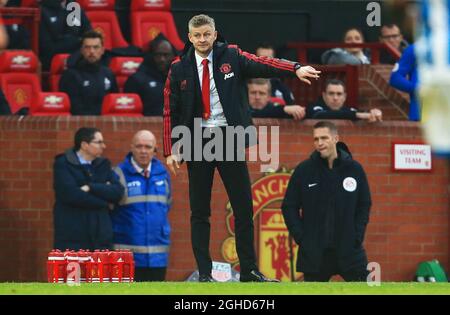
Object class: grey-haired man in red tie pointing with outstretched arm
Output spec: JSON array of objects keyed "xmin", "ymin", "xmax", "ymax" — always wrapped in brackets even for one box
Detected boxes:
[{"xmin": 163, "ymin": 14, "xmax": 320, "ymax": 282}]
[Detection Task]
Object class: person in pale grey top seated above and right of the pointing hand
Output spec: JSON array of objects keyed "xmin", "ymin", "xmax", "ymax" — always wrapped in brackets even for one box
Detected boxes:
[{"xmin": 321, "ymin": 28, "xmax": 370, "ymax": 65}]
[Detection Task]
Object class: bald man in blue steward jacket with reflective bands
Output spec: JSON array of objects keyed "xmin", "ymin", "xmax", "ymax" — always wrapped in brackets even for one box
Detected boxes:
[{"xmin": 112, "ymin": 130, "xmax": 171, "ymax": 281}]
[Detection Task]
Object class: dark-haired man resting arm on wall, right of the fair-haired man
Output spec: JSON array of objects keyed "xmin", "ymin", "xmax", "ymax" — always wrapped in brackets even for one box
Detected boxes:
[{"xmin": 306, "ymin": 79, "xmax": 383, "ymax": 122}]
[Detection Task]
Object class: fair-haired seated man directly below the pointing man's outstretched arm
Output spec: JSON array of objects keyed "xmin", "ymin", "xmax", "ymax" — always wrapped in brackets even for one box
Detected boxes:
[{"xmin": 247, "ymin": 78, "xmax": 305, "ymax": 120}]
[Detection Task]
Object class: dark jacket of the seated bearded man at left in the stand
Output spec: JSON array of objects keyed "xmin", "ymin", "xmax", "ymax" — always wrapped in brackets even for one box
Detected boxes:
[{"xmin": 59, "ymin": 57, "xmax": 119, "ymax": 115}]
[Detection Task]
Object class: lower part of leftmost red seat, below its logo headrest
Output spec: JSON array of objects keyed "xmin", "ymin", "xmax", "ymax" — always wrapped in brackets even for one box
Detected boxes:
[{"xmin": 0, "ymin": 72, "xmax": 41, "ymax": 114}]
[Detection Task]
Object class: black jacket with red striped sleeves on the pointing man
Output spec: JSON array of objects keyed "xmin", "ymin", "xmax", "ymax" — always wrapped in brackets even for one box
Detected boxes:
[{"xmin": 163, "ymin": 40, "xmax": 295, "ymax": 156}]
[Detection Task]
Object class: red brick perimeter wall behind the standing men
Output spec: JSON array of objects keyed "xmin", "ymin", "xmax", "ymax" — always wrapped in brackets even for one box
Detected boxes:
[{"xmin": 0, "ymin": 116, "xmax": 449, "ymax": 281}]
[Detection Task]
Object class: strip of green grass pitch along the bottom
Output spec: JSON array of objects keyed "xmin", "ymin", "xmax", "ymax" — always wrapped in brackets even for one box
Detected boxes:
[{"xmin": 0, "ymin": 282, "xmax": 450, "ymax": 295}]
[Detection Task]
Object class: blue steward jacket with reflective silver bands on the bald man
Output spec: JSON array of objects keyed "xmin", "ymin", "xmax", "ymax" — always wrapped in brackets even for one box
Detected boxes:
[{"xmin": 111, "ymin": 153, "xmax": 171, "ymax": 268}]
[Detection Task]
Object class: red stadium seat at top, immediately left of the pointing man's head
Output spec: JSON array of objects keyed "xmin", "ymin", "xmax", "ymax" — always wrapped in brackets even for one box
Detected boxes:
[{"xmin": 130, "ymin": 0, "xmax": 184, "ymax": 51}]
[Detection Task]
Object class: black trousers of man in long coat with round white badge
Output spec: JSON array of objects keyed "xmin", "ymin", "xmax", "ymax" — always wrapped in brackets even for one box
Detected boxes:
[{"xmin": 304, "ymin": 249, "xmax": 369, "ymax": 282}]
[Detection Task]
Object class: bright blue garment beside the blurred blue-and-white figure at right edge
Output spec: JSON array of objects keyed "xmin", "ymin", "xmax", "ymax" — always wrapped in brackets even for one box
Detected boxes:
[{"xmin": 389, "ymin": 44, "xmax": 421, "ymax": 121}]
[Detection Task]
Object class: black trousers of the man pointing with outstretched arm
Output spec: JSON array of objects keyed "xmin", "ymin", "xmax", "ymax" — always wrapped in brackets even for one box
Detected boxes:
[{"xmin": 187, "ymin": 161, "xmax": 256, "ymax": 274}]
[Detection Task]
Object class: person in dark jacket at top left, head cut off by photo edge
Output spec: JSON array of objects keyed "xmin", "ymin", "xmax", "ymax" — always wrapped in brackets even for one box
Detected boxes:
[{"xmin": 39, "ymin": 0, "xmax": 92, "ymax": 70}]
